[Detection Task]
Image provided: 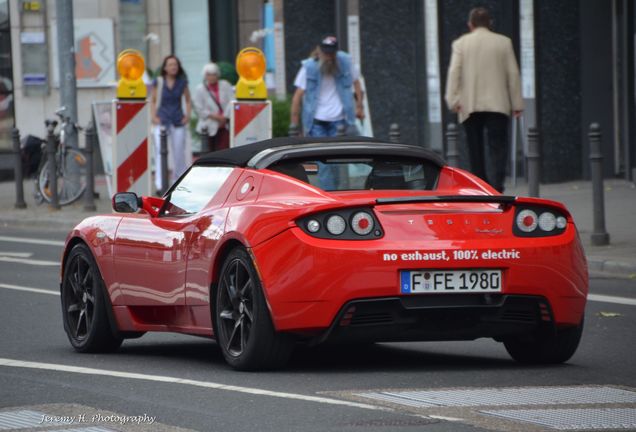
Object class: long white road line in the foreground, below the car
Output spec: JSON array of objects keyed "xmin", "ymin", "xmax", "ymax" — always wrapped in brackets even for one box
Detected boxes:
[{"xmin": 0, "ymin": 358, "xmax": 393, "ymax": 411}]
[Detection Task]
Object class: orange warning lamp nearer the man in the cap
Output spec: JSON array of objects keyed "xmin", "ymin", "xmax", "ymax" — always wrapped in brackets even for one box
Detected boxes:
[{"xmin": 236, "ymin": 47, "xmax": 267, "ymax": 99}]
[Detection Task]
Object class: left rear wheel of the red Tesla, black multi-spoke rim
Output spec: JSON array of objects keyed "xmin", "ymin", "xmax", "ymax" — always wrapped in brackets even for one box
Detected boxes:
[{"xmin": 213, "ymin": 248, "xmax": 293, "ymax": 371}]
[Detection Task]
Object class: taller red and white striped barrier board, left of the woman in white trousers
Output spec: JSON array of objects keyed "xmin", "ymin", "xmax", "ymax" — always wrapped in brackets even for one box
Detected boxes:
[{"xmin": 112, "ymin": 100, "xmax": 151, "ymax": 196}]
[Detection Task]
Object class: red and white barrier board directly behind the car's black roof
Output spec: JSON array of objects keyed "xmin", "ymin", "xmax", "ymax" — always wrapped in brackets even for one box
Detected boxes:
[{"xmin": 230, "ymin": 100, "xmax": 272, "ymax": 147}]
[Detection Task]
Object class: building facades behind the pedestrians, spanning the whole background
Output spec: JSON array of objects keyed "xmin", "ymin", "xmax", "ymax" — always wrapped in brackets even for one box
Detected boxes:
[{"xmin": 0, "ymin": 0, "xmax": 636, "ymax": 182}]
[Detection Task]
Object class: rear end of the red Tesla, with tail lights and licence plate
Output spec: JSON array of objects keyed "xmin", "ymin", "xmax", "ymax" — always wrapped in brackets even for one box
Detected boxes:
[{"xmin": 247, "ymin": 142, "xmax": 588, "ymax": 363}]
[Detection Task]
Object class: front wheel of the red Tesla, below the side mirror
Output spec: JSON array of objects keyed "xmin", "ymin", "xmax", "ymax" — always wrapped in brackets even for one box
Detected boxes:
[{"xmin": 60, "ymin": 243, "xmax": 123, "ymax": 353}]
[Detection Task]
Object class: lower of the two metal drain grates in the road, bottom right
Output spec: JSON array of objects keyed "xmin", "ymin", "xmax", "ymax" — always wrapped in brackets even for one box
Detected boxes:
[{"xmin": 481, "ymin": 408, "xmax": 636, "ymax": 430}]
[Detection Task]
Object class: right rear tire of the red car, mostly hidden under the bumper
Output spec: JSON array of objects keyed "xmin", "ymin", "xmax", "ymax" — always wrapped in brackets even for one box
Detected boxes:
[{"xmin": 504, "ymin": 318, "xmax": 584, "ymax": 364}]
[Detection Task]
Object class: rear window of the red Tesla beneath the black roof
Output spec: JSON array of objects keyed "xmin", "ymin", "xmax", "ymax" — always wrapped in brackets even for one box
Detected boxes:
[{"xmin": 268, "ymin": 156, "xmax": 440, "ymax": 191}]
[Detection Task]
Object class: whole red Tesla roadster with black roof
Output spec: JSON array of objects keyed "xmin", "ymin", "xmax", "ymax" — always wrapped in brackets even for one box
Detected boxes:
[{"xmin": 60, "ymin": 138, "xmax": 588, "ymax": 370}]
